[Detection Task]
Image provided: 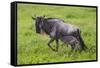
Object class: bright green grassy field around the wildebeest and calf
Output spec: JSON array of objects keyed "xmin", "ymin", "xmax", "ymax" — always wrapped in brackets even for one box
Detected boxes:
[{"xmin": 17, "ymin": 4, "xmax": 96, "ymax": 65}]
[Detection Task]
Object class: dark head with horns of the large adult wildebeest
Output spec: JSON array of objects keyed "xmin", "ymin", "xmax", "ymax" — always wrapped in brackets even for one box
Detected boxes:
[{"xmin": 32, "ymin": 16, "xmax": 45, "ymax": 33}]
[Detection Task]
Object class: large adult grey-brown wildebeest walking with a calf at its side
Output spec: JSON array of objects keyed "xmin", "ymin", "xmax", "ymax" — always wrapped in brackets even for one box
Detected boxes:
[{"xmin": 32, "ymin": 16, "xmax": 86, "ymax": 51}]
